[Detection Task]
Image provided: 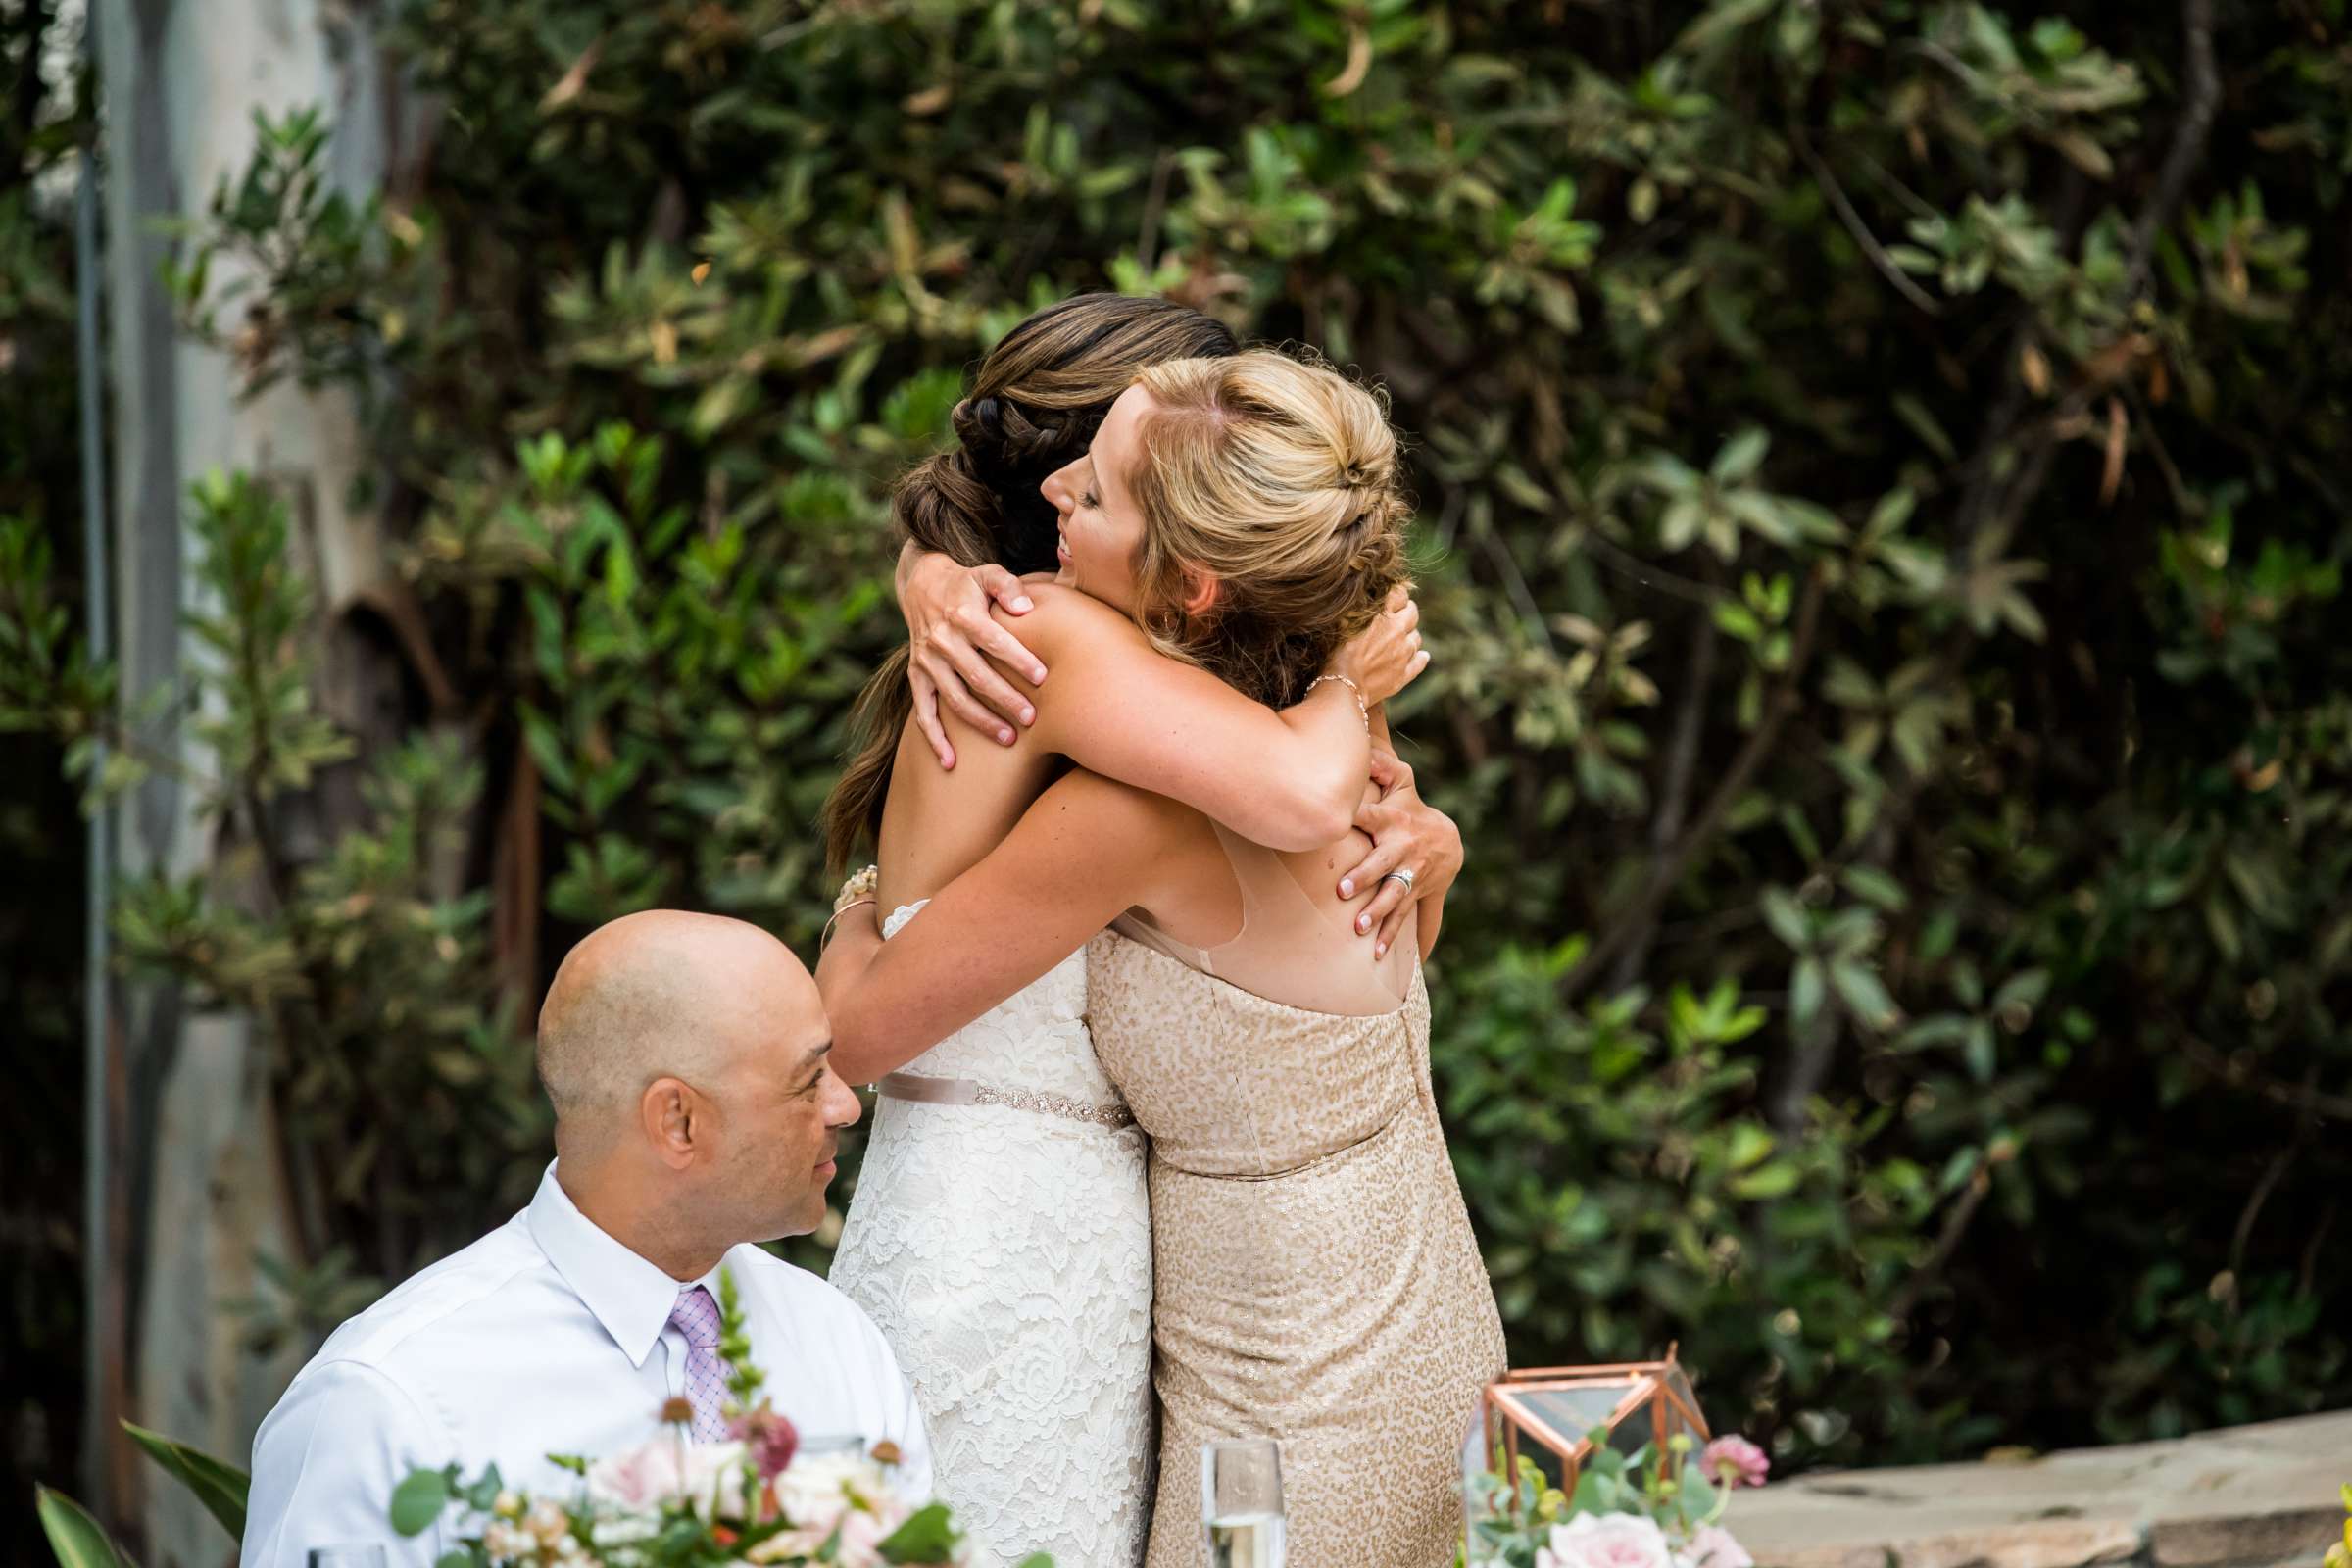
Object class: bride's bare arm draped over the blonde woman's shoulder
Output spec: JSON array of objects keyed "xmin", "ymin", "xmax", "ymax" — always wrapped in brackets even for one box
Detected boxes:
[{"xmin": 1023, "ymin": 588, "xmax": 1428, "ymax": 851}]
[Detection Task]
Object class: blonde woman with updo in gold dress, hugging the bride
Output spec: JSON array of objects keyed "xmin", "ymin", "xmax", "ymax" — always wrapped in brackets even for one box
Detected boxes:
[{"xmin": 821, "ymin": 350, "xmax": 1503, "ymax": 1568}]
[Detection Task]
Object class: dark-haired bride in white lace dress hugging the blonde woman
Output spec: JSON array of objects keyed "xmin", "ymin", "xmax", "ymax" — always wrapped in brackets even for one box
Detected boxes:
[{"xmin": 818, "ymin": 296, "xmax": 1448, "ymax": 1568}]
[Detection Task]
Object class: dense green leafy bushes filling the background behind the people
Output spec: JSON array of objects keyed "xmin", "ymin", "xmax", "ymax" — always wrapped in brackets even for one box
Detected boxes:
[{"xmin": 4, "ymin": 0, "xmax": 2352, "ymax": 1462}]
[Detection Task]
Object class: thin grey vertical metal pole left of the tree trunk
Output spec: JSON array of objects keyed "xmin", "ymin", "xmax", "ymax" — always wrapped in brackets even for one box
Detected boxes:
[{"xmin": 73, "ymin": 0, "xmax": 113, "ymax": 1519}]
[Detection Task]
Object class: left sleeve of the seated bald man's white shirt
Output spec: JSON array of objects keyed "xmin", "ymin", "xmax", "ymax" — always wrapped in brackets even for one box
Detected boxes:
[{"xmin": 240, "ymin": 1361, "xmax": 457, "ymax": 1568}]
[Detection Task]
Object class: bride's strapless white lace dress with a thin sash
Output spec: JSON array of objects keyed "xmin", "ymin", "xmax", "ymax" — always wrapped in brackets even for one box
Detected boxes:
[{"xmin": 833, "ymin": 903, "xmax": 1154, "ymax": 1568}]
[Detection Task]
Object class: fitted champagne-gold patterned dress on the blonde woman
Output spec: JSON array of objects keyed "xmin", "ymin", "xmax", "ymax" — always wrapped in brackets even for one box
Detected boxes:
[{"xmin": 1087, "ymin": 832, "xmax": 1503, "ymax": 1568}]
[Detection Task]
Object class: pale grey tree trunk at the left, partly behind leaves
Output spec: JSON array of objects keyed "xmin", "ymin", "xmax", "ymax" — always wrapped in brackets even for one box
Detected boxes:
[{"xmin": 92, "ymin": 0, "xmax": 395, "ymax": 1568}]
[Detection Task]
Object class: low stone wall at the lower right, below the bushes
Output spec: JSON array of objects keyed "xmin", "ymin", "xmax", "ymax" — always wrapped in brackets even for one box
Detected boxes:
[{"xmin": 1729, "ymin": 1410, "xmax": 2352, "ymax": 1568}]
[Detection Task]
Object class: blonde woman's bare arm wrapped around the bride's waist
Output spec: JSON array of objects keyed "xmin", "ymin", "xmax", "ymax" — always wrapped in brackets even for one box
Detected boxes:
[{"xmin": 816, "ymin": 773, "xmax": 1200, "ymax": 1084}]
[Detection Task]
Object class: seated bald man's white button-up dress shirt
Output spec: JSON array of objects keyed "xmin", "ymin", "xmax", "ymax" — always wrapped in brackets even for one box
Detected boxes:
[{"xmin": 242, "ymin": 1166, "xmax": 931, "ymax": 1568}]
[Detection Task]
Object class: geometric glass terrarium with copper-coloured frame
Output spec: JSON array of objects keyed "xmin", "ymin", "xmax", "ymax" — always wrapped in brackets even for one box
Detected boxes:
[{"xmin": 1482, "ymin": 1348, "xmax": 1707, "ymax": 1493}]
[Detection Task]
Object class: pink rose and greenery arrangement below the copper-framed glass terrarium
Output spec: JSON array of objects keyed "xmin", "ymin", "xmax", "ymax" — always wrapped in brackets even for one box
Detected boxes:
[{"xmin": 1458, "ymin": 1434, "xmax": 1771, "ymax": 1568}]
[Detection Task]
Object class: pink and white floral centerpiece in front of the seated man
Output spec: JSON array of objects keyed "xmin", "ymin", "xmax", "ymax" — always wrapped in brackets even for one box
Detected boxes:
[{"xmin": 393, "ymin": 1269, "xmax": 1054, "ymax": 1568}]
